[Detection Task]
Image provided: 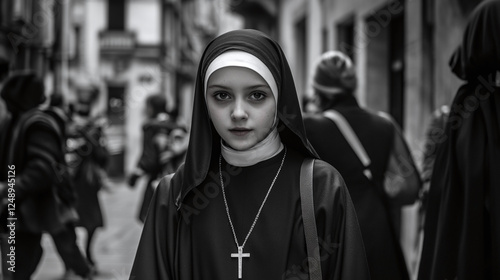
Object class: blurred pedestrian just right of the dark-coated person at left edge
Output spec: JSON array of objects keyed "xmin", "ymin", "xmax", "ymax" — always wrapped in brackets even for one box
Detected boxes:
[{"xmin": 66, "ymin": 87, "xmax": 109, "ymax": 269}]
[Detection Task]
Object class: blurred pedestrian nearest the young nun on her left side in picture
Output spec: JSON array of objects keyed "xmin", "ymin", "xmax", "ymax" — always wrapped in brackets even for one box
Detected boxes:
[{"xmin": 128, "ymin": 94, "xmax": 188, "ymax": 223}]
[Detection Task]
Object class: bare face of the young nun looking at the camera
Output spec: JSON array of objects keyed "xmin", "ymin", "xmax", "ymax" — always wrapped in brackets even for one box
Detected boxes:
[{"xmin": 206, "ymin": 66, "xmax": 276, "ymax": 151}]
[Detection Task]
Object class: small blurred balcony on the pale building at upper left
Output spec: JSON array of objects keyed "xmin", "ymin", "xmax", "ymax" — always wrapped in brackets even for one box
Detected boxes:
[{"xmin": 99, "ymin": 30, "xmax": 136, "ymax": 56}]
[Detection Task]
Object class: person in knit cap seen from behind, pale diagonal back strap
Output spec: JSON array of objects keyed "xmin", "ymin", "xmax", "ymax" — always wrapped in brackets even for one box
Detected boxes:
[{"xmin": 304, "ymin": 51, "xmax": 420, "ymax": 280}]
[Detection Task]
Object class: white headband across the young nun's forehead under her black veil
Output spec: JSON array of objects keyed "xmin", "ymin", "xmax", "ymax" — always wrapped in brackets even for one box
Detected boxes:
[{"xmin": 204, "ymin": 50, "xmax": 278, "ymax": 100}]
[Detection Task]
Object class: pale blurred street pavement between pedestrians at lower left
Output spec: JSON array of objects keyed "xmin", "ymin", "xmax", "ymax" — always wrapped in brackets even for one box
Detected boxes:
[{"xmin": 32, "ymin": 180, "xmax": 145, "ymax": 280}]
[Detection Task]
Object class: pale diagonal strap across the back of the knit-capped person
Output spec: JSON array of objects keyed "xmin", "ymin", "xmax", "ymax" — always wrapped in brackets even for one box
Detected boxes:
[{"xmin": 323, "ymin": 110, "xmax": 373, "ymax": 180}]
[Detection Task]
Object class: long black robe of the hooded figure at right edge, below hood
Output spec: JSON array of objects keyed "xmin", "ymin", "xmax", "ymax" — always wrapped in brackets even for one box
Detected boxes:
[{"xmin": 419, "ymin": 83, "xmax": 500, "ymax": 279}]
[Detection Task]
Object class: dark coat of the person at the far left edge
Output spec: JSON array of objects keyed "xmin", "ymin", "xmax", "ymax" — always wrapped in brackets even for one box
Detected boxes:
[{"xmin": 0, "ymin": 109, "xmax": 69, "ymax": 280}]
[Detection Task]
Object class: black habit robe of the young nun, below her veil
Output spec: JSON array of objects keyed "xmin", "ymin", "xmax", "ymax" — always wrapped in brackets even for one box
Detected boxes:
[{"xmin": 131, "ymin": 149, "xmax": 369, "ymax": 280}]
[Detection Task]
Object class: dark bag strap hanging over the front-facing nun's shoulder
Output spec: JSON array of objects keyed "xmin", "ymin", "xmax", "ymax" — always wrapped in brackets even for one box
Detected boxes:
[{"xmin": 300, "ymin": 159, "xmax": 323, "ymax": 280}]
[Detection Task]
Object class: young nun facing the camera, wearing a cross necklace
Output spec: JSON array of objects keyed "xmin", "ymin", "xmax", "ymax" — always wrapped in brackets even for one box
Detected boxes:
[{"xmin": 130, "ymin": 30, "xmax": 369, "ymax": 280}]
